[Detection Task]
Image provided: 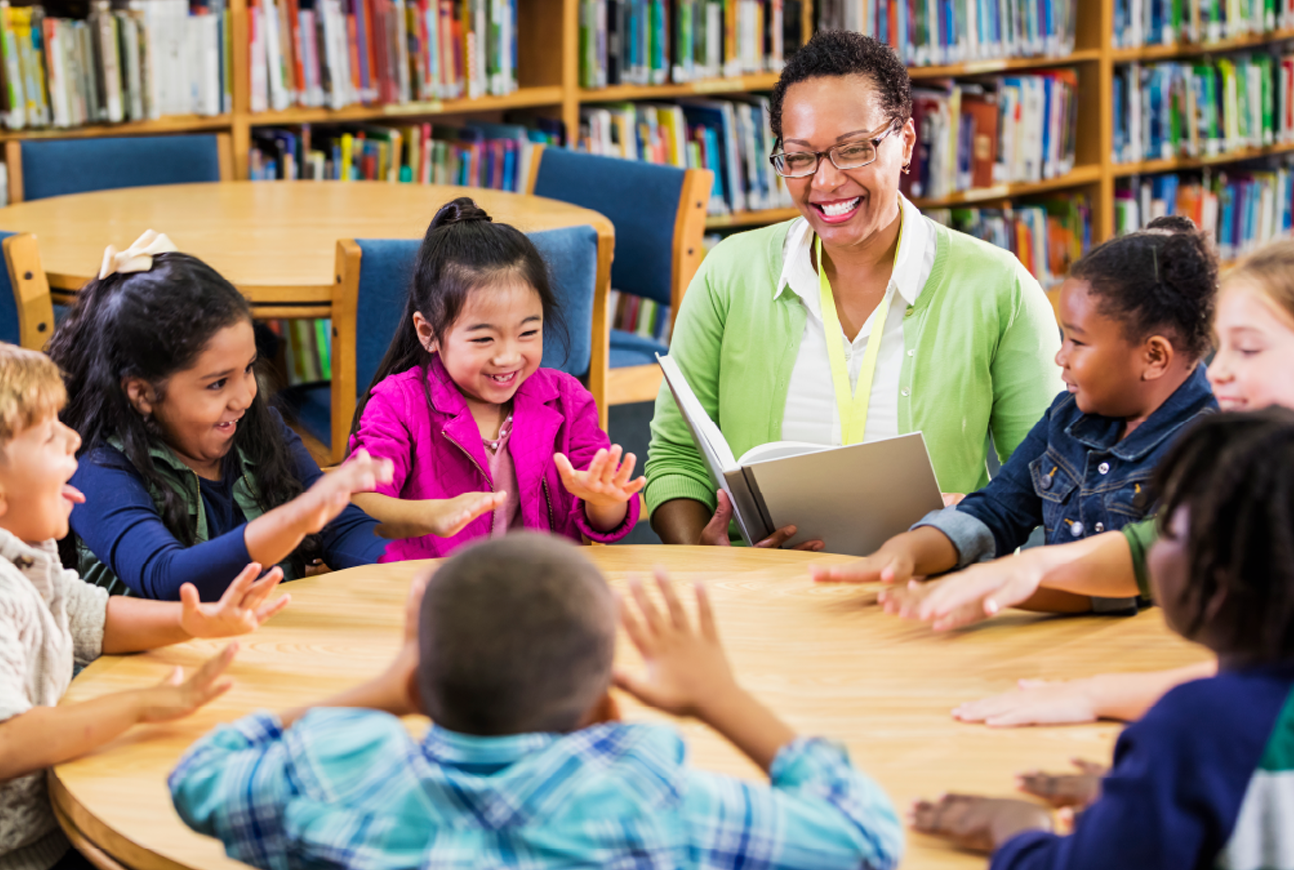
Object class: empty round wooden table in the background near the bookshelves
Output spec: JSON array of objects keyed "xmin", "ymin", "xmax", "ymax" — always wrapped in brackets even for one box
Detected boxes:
[{"xmin": 0, "ymin": 181, "xmax": 615, "ymax": 317}]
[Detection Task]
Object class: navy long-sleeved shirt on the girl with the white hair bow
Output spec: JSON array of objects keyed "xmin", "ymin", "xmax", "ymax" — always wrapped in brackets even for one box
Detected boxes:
[{"xmin": 71, "ymin": 412, "xmax": 387, "ymax": 601}]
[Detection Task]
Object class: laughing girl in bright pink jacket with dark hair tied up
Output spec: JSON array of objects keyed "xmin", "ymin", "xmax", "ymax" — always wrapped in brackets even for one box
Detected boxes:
[{"xmin": 349, "ymin": 197, "xmax": 646, "ymax": 562}]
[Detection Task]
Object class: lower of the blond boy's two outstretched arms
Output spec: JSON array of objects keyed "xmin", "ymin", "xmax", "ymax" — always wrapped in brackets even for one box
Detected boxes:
[{"xmin": 0, "ymin": 643, "xmax": 238, "ymax": 782}]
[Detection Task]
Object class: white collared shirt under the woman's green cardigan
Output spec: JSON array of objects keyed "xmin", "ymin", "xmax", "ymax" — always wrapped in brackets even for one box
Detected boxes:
[{"xmin": 774, "ymin": 194, "xmax": 937, "ymax": 445}]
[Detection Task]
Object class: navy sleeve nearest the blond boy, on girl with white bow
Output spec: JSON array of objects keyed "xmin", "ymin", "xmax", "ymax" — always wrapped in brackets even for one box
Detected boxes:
[{"xmin": 71, "ymin": 447, "xmax": 251, "ymax": 601}]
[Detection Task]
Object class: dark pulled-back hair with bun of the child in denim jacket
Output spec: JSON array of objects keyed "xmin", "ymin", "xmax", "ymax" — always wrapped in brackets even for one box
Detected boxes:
[{"xmin": 1070, "ymin": 215, "xmax": 1218, "ymax": 360}]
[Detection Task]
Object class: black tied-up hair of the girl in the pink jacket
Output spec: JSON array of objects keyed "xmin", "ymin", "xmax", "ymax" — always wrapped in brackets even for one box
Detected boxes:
[{"xmin": 351, "ymin": 197, "xmax": 569, "ymax": 435}]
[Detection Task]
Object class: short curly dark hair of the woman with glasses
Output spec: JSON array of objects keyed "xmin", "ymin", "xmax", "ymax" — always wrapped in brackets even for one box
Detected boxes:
[{"xmin": 769, "ymin": 30, "xmax": 912, "ymax": 142}]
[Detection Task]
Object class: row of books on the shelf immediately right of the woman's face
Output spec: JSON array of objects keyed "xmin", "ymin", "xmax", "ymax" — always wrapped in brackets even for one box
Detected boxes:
[{"xmin": 901, "ymin": 70, "xmax": 1078, "ymax": 199}]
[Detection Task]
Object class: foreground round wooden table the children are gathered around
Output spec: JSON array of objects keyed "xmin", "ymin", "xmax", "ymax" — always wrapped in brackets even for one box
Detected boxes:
[{"xmin": 50, "ymin": 546, "xmax": 1205, "ymax": 869}]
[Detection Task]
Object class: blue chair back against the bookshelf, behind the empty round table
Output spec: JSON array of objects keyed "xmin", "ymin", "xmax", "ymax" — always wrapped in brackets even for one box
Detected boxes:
[{"xmin": 22, "ymin": 133, "xmax": 220, "ymax": 199}]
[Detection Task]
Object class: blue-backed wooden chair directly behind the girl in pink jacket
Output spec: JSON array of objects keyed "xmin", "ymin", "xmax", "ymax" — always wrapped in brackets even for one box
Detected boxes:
[{"xmin": 280, "ymin": 227, "xmax": 609, "ymax": 462}]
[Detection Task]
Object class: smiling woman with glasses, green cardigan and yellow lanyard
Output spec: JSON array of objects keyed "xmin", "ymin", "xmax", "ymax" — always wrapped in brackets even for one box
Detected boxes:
[{"xmin": 644, "ymin": 31, "xmax": 1062, "ymax": 549}]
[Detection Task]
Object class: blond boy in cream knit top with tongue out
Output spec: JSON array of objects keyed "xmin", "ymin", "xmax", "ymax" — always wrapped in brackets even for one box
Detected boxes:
[{"xmin": 0, "ymin": 343, "xmax": 287, "ymax": 870}]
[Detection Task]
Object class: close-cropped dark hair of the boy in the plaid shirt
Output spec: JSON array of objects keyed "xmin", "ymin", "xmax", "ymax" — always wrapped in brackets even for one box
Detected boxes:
[{"xmin": 418, "ymin": 533, "xmax": 616, "ymax": 735}]
